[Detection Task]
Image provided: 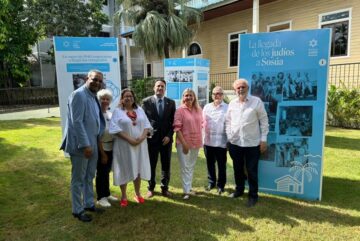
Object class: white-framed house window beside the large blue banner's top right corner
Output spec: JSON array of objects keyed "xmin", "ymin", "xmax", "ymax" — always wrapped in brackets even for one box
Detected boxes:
[{"xmin": 319, "ymin": 9, "xmax": 351, "ymax": 57}]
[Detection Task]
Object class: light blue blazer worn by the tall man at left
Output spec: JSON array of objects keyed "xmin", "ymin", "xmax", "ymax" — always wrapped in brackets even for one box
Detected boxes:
[{"xmin": 60, "ymin": 85, "xmax": 105, "ymax": 155}]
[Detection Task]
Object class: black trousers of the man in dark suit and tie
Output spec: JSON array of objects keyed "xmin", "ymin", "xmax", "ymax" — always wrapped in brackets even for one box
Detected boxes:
[{"xmin": 148, "ymin": 143, "xmax": 172, "ymax": 191}]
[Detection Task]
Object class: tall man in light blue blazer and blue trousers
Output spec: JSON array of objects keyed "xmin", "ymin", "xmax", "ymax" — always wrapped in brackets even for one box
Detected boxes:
[{"xmin": 60, "ymin": 70, "xmax": 105, "ymax": 222}]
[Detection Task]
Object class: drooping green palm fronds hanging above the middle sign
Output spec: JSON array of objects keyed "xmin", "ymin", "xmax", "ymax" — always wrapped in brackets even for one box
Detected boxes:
[{"xmin": 115, "ymin": 0, "xmax": 202, "ymax": 58}]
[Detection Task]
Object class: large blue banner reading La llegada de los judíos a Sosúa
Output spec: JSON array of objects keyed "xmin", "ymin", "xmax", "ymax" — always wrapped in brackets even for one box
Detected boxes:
[{"xmin": 238, "ymin": 29, "xmax": 330, "ymax": 200}]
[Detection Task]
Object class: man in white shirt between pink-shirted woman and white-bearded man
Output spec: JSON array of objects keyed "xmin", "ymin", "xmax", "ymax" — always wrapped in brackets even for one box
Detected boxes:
[{"xmin": 203, "ymin": 86, "xmax": 228, "ymax": 194}]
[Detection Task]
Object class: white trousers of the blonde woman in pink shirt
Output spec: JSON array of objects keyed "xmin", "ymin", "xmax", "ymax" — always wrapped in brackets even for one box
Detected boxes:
[{"xmin": 176, "ymin": 144, "xmax": 200, "ymax": 193}]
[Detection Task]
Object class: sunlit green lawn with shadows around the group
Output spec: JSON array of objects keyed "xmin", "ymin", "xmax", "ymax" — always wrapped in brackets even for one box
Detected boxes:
[{"xmin": 0, "ymin": 118, "xmax": 360, "ymax": 241}]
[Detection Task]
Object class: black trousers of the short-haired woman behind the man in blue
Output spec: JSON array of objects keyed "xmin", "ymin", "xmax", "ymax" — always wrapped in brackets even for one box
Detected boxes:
[{"xmin": 95, "ymin": 151, "xmax": 113, "ymax": 200}]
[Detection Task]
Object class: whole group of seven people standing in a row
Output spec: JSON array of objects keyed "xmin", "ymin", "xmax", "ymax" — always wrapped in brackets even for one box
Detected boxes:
[{"xmin": 61, "ymin": 70, "xmax": 268, "ymax": 222}]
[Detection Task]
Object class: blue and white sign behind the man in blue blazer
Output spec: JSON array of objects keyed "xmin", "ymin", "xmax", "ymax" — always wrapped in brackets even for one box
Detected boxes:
[{"xmin": 54, "ymin": 37, "xmax": 121, "ymax": 136}]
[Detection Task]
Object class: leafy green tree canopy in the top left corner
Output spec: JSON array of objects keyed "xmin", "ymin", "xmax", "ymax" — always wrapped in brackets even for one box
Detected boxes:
[{"xmin": 0, "ymin": 0, "xmax": 108, "ymax": 88}]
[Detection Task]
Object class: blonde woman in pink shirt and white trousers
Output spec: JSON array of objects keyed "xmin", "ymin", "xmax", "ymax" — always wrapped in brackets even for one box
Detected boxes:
[{"xmin": 174, "ymin": 88, "xmax": 203, "ymax": 200}]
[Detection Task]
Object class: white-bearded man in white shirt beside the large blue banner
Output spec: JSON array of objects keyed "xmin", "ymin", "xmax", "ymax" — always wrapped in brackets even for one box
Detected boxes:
[{"xmin": 225, "ymin": 79, "xmax": 269, "ymax": 207}]
